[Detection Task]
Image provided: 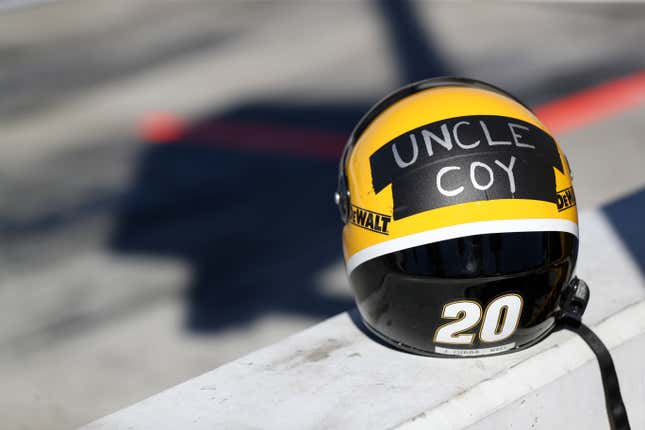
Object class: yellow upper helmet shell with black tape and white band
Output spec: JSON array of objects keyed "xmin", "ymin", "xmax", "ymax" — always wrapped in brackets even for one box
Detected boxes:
[{"xmin": 339, "ymin": 78, "xmax": 578, "ymax": 273}]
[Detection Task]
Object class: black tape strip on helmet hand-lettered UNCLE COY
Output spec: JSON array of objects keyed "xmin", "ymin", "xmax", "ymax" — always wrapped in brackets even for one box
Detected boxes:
[{"xmin": 370, "ymin": 115, "xmax": 574, "ymax": 219}]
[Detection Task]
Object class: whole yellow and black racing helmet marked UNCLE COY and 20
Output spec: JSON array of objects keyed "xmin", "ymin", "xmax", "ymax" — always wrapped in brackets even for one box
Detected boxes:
[{"xmin": 335, "ymin": 77, "xmax": 588, "ymax": 357}]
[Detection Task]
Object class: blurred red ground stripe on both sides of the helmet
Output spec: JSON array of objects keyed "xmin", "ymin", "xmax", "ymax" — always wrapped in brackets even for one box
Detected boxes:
[{"xmin": 139, "ymin": 71, "xmax": 645, "ymax": 159}]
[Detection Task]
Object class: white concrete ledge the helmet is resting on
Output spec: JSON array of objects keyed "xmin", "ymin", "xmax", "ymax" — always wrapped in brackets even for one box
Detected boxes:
[{"xmin": 85, "ymin": 212, "xmax": 645, "ymax": 430}]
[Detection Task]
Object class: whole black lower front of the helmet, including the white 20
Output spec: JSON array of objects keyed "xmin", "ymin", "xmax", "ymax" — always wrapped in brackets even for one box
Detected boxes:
[{"xmin": 350, "ymin": 232, "xmax": 578, "ymax": 357}]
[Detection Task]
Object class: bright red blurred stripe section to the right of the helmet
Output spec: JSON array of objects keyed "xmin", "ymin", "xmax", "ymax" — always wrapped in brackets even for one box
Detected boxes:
[{"xmin": 535, "ymin": 70, "xmax": 645, "ymax": 134}]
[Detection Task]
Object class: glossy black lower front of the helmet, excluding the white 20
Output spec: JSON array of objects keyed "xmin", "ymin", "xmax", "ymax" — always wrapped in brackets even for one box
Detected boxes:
[{"xmin": 351, "ymin": 232, "xmax": 578, "ymax": 354}]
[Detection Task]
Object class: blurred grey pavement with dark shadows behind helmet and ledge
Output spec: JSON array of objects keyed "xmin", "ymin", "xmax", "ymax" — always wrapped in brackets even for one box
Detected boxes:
[{"xmin": 0, "ymin": 0, "xmax": 645, "ymax": 429}]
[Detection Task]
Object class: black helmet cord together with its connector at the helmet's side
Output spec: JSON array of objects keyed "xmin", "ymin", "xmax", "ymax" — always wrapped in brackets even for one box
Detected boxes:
[{"xmin": 558, "ymin": 278, "xmax": 630, "ymax": 430}]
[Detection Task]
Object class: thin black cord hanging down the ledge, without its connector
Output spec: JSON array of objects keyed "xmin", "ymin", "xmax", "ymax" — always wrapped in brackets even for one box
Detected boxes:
[{"xmin": 564, "ymin": 322, "xmax": 631, "ymax": 430}]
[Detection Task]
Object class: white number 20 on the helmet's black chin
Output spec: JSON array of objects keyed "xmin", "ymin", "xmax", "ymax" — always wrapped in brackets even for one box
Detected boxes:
[{"xmin": 434, "ymin": 294, "xmax": 524, "ymax": 345}]
